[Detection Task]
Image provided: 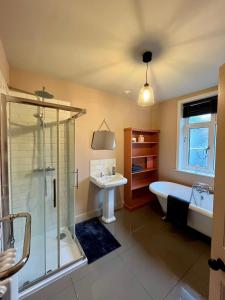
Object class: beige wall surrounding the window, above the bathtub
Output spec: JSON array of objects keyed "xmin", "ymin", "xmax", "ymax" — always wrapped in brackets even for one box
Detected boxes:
[{"xmin": 158, "ymin": 87, "xmax": 217, "ymax": 186}]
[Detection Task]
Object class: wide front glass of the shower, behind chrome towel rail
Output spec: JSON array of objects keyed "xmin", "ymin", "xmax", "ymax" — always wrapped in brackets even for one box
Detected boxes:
[{"xmin": 7, "ymin": 103, "xmax": 59, "ymax": 289}]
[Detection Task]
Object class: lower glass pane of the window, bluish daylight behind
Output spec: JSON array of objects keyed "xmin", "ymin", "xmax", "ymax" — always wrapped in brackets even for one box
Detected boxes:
[{"xmin": 188, "ymin": 127, "xmax": 209, "ymax": 168}]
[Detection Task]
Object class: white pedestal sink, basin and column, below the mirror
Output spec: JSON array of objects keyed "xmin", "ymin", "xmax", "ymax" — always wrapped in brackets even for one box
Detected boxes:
[{"xmin": 90, "ymin": 173, "xmax": 127, "ymax": 223}]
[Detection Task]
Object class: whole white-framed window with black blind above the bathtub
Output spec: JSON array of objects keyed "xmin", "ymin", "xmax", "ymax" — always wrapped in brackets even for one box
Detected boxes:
[{"xmin": 178, "ymin": 96, "xmax": 217, "ymax": 176}]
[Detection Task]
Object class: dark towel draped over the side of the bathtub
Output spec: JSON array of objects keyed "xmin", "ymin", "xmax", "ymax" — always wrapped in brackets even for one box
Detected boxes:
[{"xmin": 166, "ymin": 195, "xmax": 190, "ymax": 227}]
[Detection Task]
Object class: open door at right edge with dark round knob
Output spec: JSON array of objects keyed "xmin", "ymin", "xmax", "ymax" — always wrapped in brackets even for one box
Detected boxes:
[{"xmin": 209, "ymin": 64, "xmax": 225, "ymax": 300}]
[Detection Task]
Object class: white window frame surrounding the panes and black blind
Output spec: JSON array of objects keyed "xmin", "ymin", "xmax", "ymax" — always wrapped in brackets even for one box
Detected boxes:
[{"xmin": 176, "ymin": 91, "xmax": 217, "ymax": 177}]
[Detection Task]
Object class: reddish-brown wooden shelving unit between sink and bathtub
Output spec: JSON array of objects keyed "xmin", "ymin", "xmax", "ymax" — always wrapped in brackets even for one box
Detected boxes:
[{"xmin": 124, "ymin": 128, "xmax": 159, "ymax": 210}]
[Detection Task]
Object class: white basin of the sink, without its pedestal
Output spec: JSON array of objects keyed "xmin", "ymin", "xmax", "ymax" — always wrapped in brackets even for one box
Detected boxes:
[{"xmin": 90, "ymin": 173, "xmax": 127, "ymax": 189}]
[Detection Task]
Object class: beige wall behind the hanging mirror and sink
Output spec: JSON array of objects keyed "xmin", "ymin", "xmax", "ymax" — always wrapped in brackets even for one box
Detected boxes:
[{"xmin": 10, "ymin": 69, "xmax": 156, "ymax": 219}]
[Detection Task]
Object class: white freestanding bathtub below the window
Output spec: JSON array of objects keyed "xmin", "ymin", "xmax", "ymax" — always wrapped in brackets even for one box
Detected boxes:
[{"xmin": 149, "ymin": 181, "xmax": 213, "ymax": 237}]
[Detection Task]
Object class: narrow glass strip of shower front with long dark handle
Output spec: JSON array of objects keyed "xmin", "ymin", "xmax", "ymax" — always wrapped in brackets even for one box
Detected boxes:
[{"xmin": 43, "ymin": 108, "xmax": 59, "ymax": 273}]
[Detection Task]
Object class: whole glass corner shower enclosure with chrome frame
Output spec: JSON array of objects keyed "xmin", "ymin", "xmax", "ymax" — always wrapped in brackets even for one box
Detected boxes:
[{"xmin": 0, "ymin": 95, "xmax": 86, "ymax": 291}]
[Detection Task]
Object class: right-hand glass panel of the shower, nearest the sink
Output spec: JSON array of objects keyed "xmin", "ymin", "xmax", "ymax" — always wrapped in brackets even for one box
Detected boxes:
[{"xmin": 59, "ymin": 111, "xmax": 82, "ymax": 266}]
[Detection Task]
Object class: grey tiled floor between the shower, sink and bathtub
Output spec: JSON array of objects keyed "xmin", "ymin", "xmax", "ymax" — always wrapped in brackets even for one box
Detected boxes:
[{"xmin": 23, "ymin": 207, "xmax": 210, "ymax": 300}]
